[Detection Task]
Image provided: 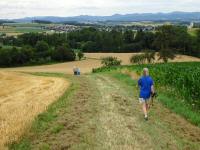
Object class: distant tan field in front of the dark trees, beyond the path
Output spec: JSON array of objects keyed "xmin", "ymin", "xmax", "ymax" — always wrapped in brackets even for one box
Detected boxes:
[{"xmin": 3, "ymin": 53, "xmax": 200, "ymax": 74}]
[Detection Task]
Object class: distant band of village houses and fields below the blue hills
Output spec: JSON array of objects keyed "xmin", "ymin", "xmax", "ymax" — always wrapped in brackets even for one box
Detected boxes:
[{"xmin": 0, "ymin": 21, "xmax": 200, "ymax": 37}]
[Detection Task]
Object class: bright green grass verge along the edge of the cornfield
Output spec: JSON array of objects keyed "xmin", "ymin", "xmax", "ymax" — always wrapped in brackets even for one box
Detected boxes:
[{"xmin": 94, "ymin": 66, "xmax": 200, "ymax": 127}]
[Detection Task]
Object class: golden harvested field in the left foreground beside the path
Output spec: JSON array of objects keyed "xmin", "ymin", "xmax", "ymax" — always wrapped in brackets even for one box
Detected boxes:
[{"xmin": 0, "ymin": 71, "xmax": 69, "ymax": 149}]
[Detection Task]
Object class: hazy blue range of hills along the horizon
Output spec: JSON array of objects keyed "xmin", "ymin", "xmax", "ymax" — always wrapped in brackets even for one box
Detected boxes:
[{"xmin": 9, "ymin": 12, "xmax": 200, "ymax": 22}]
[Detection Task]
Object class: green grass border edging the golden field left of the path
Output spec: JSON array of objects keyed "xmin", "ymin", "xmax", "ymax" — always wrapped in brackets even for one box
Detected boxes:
[{"xmin": 8, "ymin": 73, "xmax": 79, "ymax": 150}]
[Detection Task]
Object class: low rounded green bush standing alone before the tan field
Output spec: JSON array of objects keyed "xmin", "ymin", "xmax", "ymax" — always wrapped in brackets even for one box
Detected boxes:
[{"xmin": 101, "ymin": 57, "xmax": 122, "ymax": 66}]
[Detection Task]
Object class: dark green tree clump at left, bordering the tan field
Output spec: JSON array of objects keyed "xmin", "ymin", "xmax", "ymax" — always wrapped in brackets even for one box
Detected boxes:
[{"xmin": 0, "ymin": 41, "xmax": 76, "ymax": 67}]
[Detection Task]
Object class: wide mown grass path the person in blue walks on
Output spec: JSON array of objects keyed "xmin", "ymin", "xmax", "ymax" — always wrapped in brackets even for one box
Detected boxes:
[{"xmin": 10, "ymin": 74, "xmax": 200, "ymax": 150}]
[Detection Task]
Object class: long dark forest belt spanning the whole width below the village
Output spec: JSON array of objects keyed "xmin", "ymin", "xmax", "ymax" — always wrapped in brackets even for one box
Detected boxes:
[{"xmin": 0, "ymin": 25, "xmax": 200, "ymax": 57}]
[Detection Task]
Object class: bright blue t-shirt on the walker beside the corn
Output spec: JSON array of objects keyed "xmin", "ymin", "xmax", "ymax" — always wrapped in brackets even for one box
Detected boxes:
[{"xmin": 138, "ymin": 76, "xmax": 153, "ymax": 99}]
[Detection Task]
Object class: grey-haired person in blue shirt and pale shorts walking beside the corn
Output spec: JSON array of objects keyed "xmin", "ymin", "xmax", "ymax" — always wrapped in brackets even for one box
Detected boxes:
[{"xmin": 138, "ymin": 68, "xmax": 155, "ymax": 120}]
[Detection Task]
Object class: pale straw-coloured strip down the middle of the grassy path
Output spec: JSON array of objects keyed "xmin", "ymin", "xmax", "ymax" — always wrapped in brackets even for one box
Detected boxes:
[{"xmin": 93, "ymin": 75, "xmax": 152, "ymax": 150}]
